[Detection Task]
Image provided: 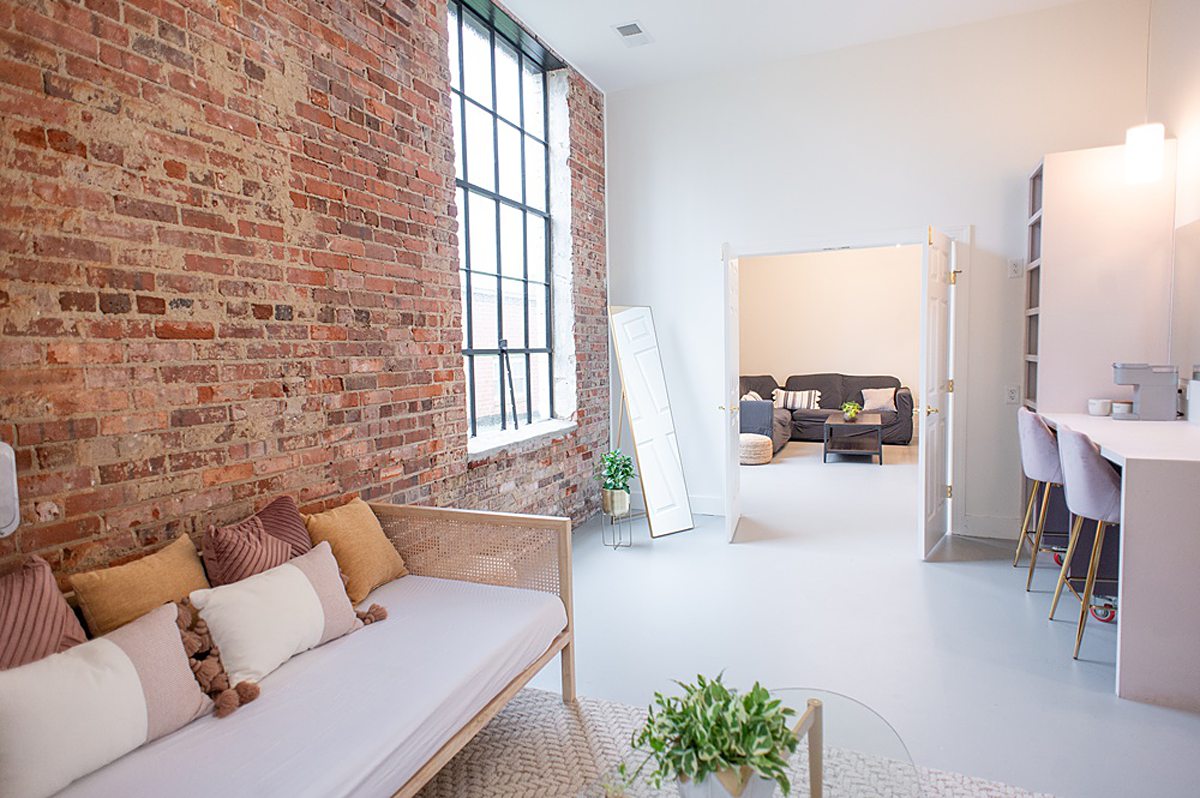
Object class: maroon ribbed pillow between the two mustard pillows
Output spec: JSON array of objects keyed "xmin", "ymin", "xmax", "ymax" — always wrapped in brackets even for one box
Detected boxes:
[{"xmin": 204, "ymin": 496, "xmax": 312, "ymax": 587}]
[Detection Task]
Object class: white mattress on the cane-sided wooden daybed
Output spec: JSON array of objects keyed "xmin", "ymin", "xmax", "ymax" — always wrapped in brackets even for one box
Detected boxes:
[{"xmin": 61, "ymin": 576, "xmax": 566, "ymax": 798}]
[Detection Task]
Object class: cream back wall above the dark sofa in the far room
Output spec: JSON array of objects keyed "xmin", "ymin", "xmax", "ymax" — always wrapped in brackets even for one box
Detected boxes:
[{"xmin": 739, "ymin": 246, "xmax": 920, "ymax": 398}]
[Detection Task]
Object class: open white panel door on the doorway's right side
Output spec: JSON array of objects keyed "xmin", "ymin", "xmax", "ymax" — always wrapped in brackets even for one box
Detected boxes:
[{"xmin": 917, "ymin": 227, "xmax": 950, "ymax": 559}]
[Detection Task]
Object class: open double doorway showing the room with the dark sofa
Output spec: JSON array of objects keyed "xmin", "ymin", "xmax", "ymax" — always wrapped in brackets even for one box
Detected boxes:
[{"xmin": 724, "ymin": 227, "xmax": 972, "ymax": 558}]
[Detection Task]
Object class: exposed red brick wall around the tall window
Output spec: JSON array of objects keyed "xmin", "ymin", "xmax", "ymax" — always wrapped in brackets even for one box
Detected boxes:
[{"xmin": 0, "ymin": 0, "xmax": 608, "ymax": 571}]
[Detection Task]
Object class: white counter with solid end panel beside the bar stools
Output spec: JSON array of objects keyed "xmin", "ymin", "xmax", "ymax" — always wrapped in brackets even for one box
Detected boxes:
[{"xmin": 1042, "ymin": 413, "xmax": 1200, "ymax": 712}]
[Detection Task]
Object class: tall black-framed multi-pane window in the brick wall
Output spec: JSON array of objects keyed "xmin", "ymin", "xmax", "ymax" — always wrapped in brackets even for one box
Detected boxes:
[{"xmin": 449, "ymin": 0, "xmax": 554, "ymax": 437}]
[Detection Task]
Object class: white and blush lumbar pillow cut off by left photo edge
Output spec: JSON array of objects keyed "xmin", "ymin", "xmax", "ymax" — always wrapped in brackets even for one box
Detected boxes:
[{"xmin": 0, "ymin": 604, "xmax": 212, "ymax": 798}]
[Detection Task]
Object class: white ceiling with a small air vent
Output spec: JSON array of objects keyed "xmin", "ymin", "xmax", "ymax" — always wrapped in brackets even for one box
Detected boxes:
[{"xmin": 504, "ymin": 0, "xmax": 1074, "ymax": 91}]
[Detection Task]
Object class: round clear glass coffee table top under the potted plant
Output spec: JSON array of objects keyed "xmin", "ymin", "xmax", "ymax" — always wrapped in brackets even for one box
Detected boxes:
[{"xmin": 580, "ymin": 688, "xmax": 924, "ymax": 798}]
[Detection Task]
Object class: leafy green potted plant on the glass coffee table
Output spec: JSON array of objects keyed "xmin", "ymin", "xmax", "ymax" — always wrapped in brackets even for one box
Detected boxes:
[{"xmin": 620, "ymin": 676, "xmax": 799, "ymax": 798}]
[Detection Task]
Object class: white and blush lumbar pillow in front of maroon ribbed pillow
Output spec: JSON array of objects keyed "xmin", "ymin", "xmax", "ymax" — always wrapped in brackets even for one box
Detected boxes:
[{"xmin": 191, "ymin": 540, "xmax": 362, "ymax": 684}]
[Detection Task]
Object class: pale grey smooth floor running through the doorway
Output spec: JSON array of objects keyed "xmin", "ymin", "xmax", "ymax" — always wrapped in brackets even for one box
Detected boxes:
[{"xmin": 534, "ymin": 443, "xmax": 1200, "ymax": 798}]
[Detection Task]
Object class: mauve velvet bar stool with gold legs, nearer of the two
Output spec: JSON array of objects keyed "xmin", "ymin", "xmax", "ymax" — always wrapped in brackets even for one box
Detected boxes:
[{"xmin": 1050, "ymin": 426, "xmax": 1121, "ymax": 659}]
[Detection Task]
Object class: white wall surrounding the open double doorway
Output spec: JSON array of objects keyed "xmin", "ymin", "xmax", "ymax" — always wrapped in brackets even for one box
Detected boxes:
[{"xmin": 607, "ymin": 0, "xmax": 1146, "ymax": 535}]
